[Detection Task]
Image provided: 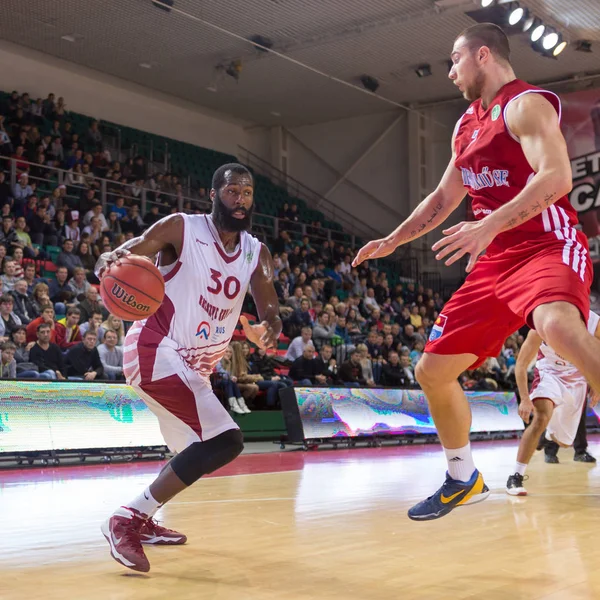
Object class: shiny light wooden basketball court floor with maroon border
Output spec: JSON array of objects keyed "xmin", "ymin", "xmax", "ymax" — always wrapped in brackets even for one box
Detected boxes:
[{"xmin": 0, "ymin": 437, "xmax": 600, "ymax": 600}]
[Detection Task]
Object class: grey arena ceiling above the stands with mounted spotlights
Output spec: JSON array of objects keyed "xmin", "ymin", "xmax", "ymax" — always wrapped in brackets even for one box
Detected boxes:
[{"xmin": 0, "ymin": 0, "xmax": 600, "ymax": 126}]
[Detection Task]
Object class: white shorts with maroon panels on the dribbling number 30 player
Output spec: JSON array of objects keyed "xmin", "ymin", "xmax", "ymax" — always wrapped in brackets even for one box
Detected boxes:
[{"xmin": 123, "ymin": 332, "xmax": 239, "ymax": 452}]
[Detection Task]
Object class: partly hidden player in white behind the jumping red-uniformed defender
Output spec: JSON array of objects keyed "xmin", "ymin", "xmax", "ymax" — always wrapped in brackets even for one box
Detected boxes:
[{"xmin": 506, "ymin": 311, "xmax": 600, "ymax": 496}]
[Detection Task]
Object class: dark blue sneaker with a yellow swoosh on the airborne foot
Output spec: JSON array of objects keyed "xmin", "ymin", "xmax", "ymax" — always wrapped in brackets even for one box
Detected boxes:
[{"xmin": 408, "ymin": 469, "xmax": 490, "ymax": 521}]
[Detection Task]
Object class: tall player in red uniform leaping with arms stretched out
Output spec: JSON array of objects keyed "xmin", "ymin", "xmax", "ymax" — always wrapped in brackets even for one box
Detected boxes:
[{"xmin": 354, "ymin": 23, "xmax": 600, "ymax": 520}]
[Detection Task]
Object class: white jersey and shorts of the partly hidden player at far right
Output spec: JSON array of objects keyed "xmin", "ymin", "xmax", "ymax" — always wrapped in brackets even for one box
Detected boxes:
[{"xmin": 529, "ymin": 311, "xmax": 600, "ymax": 446}]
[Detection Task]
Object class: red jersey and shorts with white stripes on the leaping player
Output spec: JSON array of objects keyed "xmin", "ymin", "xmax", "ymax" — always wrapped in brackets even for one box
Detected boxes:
[{"xmin": 425, "ymin": 79, "xmax": 592, "ymax": 368}]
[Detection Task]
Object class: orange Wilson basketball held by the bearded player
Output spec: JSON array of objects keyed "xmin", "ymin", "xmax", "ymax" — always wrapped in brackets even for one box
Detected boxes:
[{"xmin": 100, "ymin": 254, "xmax": 165, "ymax": 321}]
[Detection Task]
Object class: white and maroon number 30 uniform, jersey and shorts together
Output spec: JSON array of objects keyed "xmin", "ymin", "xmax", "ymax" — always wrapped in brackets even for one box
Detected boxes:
[{"xmin": 123, "ymin": 215, "xmax": 261, "ymax": 452}]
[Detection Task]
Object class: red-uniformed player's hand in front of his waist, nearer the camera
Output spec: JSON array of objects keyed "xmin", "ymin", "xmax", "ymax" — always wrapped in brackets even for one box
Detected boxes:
[{"xmin": 431, "ymin": 219, "xmax": 496, "ymax": 273}]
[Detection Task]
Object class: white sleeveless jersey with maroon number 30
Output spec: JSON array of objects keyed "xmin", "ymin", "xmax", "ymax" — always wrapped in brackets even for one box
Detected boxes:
[{"xmin": 131, "ymin": 214, "xmax": 261, "ymax": 378}]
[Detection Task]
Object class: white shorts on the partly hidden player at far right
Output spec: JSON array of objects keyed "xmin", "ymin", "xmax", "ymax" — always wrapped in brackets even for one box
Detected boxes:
[{"xmin": 530, "ymin": 372, "xmax": 587, "ymax": 446}]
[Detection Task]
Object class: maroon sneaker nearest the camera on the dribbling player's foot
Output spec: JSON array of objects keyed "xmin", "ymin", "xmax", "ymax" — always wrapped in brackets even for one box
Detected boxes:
[{"xmin": 102, "ymin": 506, "xmax": 150, "ymax": 573}]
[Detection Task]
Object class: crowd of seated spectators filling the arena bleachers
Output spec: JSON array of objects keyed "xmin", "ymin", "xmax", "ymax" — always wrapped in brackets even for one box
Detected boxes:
[{"xmin": 0, "ymin": 92, "xmax": 522, "ymax": 413}]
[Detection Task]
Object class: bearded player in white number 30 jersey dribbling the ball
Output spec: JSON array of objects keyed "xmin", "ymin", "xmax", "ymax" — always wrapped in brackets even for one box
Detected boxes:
[{"xmin": 96, "ymin": 164, "xmax": 281, "ymax": 572}]
